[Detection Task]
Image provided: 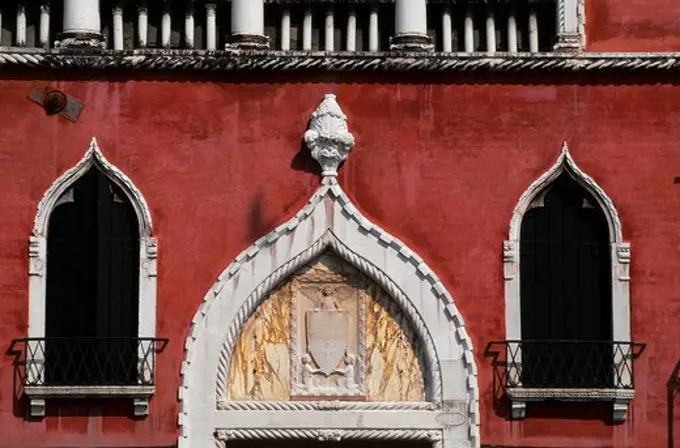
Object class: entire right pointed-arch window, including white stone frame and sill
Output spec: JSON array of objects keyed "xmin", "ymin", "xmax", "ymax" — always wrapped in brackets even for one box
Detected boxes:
[{"xmin": 503, "ymin": 144, "xmax": 644, "ymax": 422}]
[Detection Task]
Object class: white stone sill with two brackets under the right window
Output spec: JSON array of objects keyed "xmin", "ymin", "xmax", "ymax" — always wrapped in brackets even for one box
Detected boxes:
[{"xmin": 505, "ymin": 387, "xmax": 635, "ymax": 423}]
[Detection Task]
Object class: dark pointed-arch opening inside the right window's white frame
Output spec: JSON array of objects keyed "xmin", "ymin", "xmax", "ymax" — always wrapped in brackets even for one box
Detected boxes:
[{"xmin": 520, "ymin": 173, "xmax": 612, "ymax": 387}]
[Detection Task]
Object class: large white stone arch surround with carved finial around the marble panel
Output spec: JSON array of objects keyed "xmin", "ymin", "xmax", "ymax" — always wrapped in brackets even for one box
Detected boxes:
[{"xmin": 178, "ymin": 95, "xmax": 480, "ymax": 448}]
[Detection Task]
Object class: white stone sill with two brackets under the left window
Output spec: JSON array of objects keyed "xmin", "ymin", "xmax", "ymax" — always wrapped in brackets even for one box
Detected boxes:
[{"xmin": 24, "ymin": 385, "xmax": 154, "ymax": 418}]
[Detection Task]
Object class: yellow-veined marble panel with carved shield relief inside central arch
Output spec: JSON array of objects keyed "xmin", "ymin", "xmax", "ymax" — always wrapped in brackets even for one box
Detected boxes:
[{"xmin": 228, "ymin": 253, "xmax": 425, "ymax": 401}]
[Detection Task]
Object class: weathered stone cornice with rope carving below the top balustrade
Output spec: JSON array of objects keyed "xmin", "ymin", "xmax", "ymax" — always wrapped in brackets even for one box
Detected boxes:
[{"xmin": 0, "ymin": 47, "xmax": 680, "ymax": 74}]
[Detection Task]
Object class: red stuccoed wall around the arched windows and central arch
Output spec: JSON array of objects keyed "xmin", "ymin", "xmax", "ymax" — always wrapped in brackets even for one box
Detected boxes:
[{"xmin": 0, "ymin": 75, "xmax": 680, "ymax": 448}]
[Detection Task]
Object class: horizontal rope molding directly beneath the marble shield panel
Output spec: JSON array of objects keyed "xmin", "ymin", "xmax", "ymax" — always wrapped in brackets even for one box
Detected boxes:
[{"xmin": 217, "ymin": 400, "xmax": 437, "ymax": 411}]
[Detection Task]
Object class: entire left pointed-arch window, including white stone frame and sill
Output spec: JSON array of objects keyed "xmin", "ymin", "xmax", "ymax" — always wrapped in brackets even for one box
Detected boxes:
[{"xmin": 23, "ymin": 139, "xmax": 159, "ymax": 417}]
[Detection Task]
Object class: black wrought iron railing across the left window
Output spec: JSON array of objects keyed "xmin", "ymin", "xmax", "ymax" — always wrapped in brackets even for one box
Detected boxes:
[{"xmin": 15, "ymin": 338, "xmax": 167, "ymax": 395}]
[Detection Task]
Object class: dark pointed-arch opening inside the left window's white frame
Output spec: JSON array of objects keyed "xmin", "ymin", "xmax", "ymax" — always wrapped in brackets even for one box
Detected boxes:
[{"xmin": 45, "ymin": 168, "xmax": 139, "ymax": 384}]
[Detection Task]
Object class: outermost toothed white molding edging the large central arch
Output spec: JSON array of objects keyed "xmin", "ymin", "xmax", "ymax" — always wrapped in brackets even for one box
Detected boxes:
[{"xmin": 177, "ymin": 177, "xmax": 480, "ymax": 447}]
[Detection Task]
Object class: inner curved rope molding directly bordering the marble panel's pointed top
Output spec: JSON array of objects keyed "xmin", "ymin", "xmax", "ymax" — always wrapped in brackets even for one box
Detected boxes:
[{"xmin": 216, "ymin": 230, "xmax": 442, "ymax": 407}]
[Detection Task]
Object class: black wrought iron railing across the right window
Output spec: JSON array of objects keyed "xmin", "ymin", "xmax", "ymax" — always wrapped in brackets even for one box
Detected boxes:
[{"xmin": 489, "ymin": 340, "xmax": 645, "ymax": 390}]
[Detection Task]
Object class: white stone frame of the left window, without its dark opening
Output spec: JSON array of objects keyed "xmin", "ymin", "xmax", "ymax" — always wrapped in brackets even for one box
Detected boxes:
[{"xmin": 24, "ymin": 137, "xmax": 158, "ymax": 417}]
